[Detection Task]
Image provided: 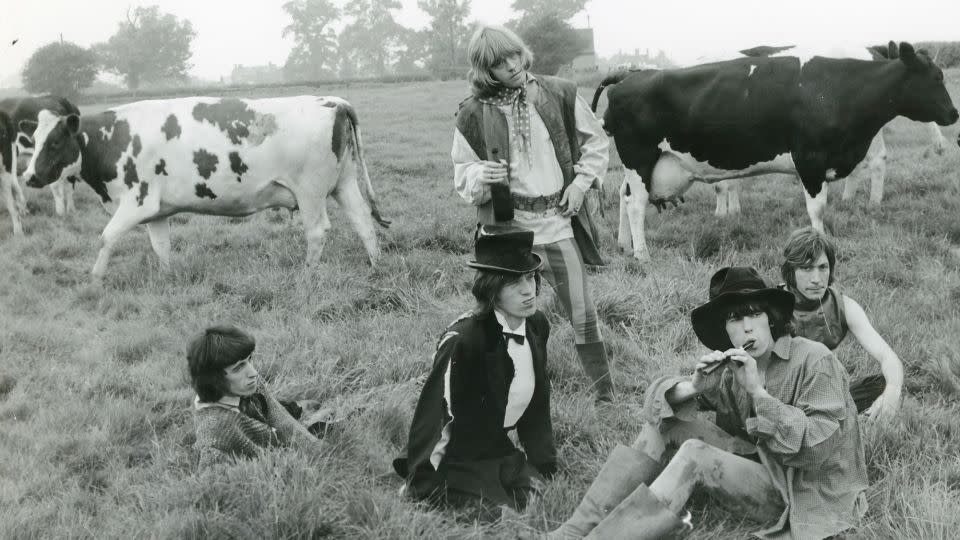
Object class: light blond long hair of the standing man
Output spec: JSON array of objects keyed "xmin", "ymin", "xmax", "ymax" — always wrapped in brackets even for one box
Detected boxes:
[{"xmin": 467, "ymin": 25, "xmax": 533, "ymax": 97}]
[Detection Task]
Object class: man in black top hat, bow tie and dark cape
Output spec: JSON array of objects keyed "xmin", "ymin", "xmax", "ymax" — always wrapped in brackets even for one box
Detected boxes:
[{"xmin": 393, "ymin": 225, "xmax": 557, "ymax": 520}]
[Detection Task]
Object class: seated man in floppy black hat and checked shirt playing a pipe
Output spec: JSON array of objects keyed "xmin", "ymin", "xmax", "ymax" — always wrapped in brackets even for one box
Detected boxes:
[{"xmin": 550, "ymin": 267, "xmax": 868, "ymax": 539}]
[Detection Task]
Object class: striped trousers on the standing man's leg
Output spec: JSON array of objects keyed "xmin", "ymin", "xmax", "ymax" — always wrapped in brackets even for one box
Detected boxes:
[{"xmin": 533, "ymin": 238, "xmax": 603, "ymax": 345}]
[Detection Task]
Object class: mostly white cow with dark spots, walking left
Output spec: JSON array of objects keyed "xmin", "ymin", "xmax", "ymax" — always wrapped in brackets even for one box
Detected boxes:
[{"xmin": 24, "ymin": 96, "xmax": 389, "ymax": 279}]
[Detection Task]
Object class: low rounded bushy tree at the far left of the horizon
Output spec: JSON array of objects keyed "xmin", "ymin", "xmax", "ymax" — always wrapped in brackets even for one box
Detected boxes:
[{"xmin": 23, "ymin": 41, "xmax": 99, "ymax": 98}]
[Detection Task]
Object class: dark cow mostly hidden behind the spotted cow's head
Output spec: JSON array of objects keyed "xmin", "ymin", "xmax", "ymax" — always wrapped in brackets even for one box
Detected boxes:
[{"xmin": 0, "ymin": 95, "xmax": 80, "ymax": 216}]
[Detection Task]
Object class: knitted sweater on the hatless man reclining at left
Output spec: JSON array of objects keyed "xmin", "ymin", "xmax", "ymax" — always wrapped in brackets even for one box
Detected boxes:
[{"xmin": 194, "ymin": 384, "xmax": 319, "ymax": 469}]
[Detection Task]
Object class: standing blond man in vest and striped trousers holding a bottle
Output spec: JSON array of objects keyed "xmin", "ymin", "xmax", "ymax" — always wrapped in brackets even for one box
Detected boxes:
[{"xmin": 451, "ymin": 26, "xmax": 613, "ymax": 402}]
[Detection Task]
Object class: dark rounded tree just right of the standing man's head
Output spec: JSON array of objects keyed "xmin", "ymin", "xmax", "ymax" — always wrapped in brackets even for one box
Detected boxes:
[{"xmin": 519, "ymin": 12, "xmax": 580, "ymax": 75}]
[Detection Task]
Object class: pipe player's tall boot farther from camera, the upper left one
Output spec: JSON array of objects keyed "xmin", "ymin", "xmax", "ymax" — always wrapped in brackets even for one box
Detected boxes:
[{"xmin": 547, "ymin": 444, "xmax": 660, "ymax": 540}]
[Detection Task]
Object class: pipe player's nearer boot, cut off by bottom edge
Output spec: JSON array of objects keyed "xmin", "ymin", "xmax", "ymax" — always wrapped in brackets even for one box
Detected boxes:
[{"xmin": 587, "ymin": 484, "xmax": 684, "ymax": 540}]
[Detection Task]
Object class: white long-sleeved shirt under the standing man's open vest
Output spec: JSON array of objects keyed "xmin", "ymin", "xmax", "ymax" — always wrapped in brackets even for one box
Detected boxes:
[{"xmin": 450, "ymin": 79, "xmax": 610, "ymax": 245}]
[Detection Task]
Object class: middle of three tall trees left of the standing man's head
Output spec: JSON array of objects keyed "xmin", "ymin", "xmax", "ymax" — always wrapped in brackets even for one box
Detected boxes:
[{"xmin": 340, "ymin": 0, "xmax": 407, "ymax": 77}]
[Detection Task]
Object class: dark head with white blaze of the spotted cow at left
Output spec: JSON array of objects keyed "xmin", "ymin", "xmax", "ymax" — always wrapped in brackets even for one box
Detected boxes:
[{"xmin": 20, "ymin": 110, "xmax": 80, "ymax": 188}]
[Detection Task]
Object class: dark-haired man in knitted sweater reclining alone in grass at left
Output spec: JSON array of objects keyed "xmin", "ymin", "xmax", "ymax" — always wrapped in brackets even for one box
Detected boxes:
[{"xmin": 187, "ymin": 326, "xmax": 320, "ymax": 468}]
